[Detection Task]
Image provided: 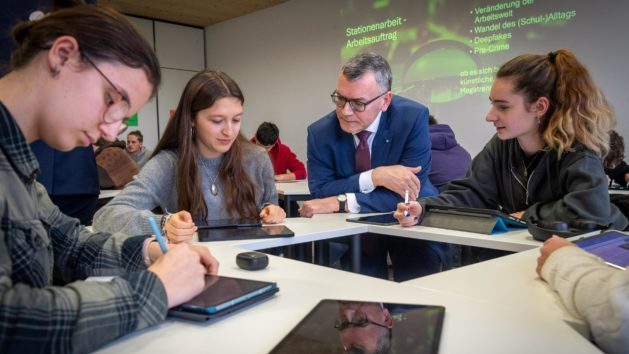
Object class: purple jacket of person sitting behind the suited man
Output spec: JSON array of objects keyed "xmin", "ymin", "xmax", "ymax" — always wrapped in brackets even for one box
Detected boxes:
[{"xmin": 428, "ymin": 124, "xmax": 472, "ymax": 189}]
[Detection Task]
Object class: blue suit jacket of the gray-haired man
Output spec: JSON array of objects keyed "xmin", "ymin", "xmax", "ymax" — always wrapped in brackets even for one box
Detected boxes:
[{"xmin": 307, "ymin": 96, "xmax": 438, "ymax": 213}]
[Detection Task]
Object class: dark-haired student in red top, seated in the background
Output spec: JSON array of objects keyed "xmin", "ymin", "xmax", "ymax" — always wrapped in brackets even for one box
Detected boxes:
[{"xmin": 251, "ymin": 122, "xmax": 307, "ymax": 181}]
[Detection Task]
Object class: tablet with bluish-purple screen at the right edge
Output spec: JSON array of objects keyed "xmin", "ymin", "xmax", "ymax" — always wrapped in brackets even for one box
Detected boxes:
[{"xmin": 575, "ymin": 230, "xmax": 629, "ymax": 269}]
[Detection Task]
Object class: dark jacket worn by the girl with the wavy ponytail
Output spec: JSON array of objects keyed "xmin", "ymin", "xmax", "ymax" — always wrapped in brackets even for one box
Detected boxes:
[{"xmin": 421, "ymin": 136, "xmax": 627, "ymax": 230}]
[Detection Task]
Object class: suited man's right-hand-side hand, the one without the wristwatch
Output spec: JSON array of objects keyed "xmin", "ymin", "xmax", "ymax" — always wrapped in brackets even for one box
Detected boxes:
[{"xmin": 371, "ymin": 165, "xmax": 422, "ymax": 200}]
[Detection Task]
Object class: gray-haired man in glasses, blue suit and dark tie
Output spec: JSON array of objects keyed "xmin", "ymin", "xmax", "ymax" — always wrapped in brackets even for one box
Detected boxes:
[{"xmin": 300, "ymin": 53, "xmax": 449, "ymax": 281}]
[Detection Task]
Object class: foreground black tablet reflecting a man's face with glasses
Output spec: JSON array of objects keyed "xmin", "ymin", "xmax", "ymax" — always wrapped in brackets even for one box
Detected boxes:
[{"xmin": 271, "ymin": 300, "xmax": 445, "ymax": 354}]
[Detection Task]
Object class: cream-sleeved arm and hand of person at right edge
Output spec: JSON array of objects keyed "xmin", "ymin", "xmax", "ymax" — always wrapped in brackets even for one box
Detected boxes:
[{"xmin": 537, "ymin": 236, "xmax": 629, "ymax": 354}]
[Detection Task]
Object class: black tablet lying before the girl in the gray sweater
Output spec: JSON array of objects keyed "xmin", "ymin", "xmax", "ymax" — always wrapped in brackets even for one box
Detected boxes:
[{"xmin": 197, "ymin": 225, "xmax": 295, "ymax": 242}]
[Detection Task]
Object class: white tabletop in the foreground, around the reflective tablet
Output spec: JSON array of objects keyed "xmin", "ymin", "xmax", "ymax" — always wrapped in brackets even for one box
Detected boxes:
[{"xmin": 100, "ymin": 243, "xmax": 599, "ymax": 354}]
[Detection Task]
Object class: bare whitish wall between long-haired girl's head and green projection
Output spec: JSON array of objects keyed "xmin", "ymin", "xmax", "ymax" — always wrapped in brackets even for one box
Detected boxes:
[{"xmin": 205, "ymin": 0, "xmax": 341, "ymax": 162}]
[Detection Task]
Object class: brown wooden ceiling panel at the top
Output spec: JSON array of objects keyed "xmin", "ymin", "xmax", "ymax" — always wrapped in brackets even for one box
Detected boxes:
[{"xmin": 98, "ymin": 0, "xmax": 289, "ymax": 27}]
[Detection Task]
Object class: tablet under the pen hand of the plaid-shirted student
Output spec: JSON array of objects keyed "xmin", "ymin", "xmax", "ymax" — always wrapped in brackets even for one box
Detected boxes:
[{"xmin": 169, "ymin": 275, "xmax": 279, "ymax": 320}]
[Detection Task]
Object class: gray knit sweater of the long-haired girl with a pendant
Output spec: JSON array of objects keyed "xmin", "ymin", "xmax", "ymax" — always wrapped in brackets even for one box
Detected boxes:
[{"xmin": 92, "ymin": 144, "xmax": 277, "ymax": 235}]
